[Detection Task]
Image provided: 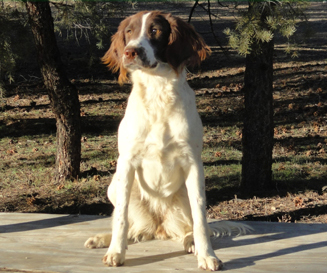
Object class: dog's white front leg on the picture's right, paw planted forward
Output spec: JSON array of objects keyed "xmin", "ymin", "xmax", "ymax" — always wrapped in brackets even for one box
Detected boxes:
[{"xmin": 186, "ymin": 160, "xmax": 222, "ymax": 271}]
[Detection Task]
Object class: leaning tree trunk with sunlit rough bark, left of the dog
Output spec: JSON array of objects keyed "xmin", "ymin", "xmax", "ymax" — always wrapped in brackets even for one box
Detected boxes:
[{"xmin": 25, "ymin": 1, "xmax": 81, "ymax": 183}]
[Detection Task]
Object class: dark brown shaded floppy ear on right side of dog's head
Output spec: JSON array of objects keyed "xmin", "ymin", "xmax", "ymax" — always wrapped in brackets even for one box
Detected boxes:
[{"xmin": 166, "ymin": 14, "xmax": 211, "ymax": 72}]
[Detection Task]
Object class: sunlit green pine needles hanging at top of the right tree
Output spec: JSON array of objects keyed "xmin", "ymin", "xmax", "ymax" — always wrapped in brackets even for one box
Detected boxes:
[{"xmin": 224, "ymin": 0, "xmax": 306, "ymax": 56}]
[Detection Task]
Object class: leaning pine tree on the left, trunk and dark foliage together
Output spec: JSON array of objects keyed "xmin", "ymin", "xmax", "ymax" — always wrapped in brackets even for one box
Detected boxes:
[{"xmin": 0, "ymin": 0, "xmax": 123, "ymax": 183}]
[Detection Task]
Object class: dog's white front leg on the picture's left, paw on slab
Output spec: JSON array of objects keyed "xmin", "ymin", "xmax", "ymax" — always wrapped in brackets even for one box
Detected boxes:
[{"xmin": 103, "ymin": 157, "xmax": 135, "ymax": 266}]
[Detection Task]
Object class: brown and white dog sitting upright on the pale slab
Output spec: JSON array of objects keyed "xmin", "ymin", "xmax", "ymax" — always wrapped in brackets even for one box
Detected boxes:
[{"xmin": 85, "ymin": 11, "xmax": 249, "ymax": 270}]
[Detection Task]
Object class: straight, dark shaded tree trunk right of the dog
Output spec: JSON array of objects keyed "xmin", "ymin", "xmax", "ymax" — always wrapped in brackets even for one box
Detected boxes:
[{"xmin": 241, "ymin": 3, "xmax": 274, "ymax": 194}]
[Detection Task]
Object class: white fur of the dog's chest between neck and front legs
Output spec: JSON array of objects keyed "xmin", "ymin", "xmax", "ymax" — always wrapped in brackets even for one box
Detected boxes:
[{"xmin": 119, "ymin": 67, "xmax": 202, "ymax": 197}]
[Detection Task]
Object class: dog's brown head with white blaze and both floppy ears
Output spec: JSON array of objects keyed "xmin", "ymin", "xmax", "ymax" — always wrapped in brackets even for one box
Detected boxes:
[{"xmin": 102, "ymin": 11, "xmax": 211, "ymax": 83}]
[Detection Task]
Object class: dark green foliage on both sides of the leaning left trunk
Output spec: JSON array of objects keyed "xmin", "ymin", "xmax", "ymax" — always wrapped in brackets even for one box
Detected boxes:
[{"xmin": 0, "ymin": 0, "xmax": 126, "ymax": 84}]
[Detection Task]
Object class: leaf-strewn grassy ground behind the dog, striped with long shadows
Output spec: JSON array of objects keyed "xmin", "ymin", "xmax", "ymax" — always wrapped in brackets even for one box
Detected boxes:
[{"xmin": 0, "ymin": 3, "xmax": 327, "ymax": 223}]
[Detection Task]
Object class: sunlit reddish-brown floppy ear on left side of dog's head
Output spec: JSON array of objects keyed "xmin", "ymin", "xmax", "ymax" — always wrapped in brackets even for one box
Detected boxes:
[{"xmin": 101, "ymin": 18, "xmax": 130, "ymax": 84}]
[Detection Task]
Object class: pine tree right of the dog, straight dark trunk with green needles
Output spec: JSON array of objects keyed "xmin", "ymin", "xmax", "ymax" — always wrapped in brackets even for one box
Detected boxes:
[{"xmin": 225, "ymin": 0, "xmax": 304, "ymax": 194}]
